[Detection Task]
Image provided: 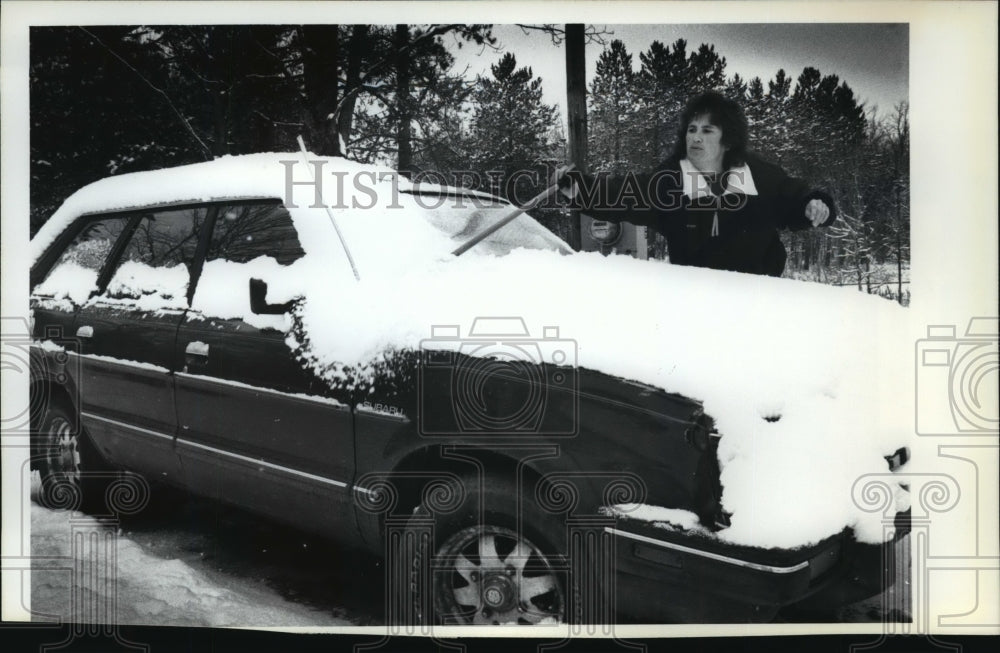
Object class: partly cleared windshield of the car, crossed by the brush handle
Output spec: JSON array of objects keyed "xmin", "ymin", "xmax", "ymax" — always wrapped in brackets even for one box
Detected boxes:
[{"xmin": 406, "ymin": 193, "xmax": 572, "ymax": 256}]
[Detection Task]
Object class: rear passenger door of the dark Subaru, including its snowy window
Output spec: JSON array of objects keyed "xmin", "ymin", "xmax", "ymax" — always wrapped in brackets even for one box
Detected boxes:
[{"xmin": 65, "ymin": 206, "xmax": 208, "ymax": 480}]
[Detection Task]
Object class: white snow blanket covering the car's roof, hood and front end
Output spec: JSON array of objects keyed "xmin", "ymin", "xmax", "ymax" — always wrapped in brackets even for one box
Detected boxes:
[{"xmin": 32, "ymin": 154, "xmax": 912, "ymax": 547}]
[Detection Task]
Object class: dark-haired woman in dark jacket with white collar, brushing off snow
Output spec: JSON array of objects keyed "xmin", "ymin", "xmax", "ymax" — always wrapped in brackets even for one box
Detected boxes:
[{"xmin": 562, "ymin": 92, "xmax": 836, "ymax": 277}]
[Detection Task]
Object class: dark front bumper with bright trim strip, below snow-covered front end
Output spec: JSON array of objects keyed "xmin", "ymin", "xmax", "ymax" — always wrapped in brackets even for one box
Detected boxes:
[{"xmin": 605, "ymin": 514, "xmax": 909, "ymax": 623}]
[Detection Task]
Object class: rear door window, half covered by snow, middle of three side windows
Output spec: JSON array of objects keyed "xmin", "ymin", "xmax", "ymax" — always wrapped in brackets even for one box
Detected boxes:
[{"xmin": 101, "ymin": 206, "xmax": 208, "ymax": 310}]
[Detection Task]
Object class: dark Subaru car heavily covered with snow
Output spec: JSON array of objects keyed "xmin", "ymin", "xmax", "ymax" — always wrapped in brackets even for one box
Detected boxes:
[{"xmin": 25, "ymin": 154, "xmax": 907, "ymax": 624}]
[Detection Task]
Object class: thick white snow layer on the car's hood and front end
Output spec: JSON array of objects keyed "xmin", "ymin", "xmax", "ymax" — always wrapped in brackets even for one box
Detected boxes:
[{"xmin": 288, "ymin": 250, "xmax": 909, "ymax": 546}]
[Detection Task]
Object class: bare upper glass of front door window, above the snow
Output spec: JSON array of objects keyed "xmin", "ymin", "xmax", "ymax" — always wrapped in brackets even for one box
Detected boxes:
[{"xmin": 205, "ymin": 202, "xmax": 305, "ymax": 265}]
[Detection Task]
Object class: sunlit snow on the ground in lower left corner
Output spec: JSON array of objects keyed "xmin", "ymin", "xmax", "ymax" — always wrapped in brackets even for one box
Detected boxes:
[{"xmin": 31, "ymin": 503, "xmax": 351, "ymax": 627}]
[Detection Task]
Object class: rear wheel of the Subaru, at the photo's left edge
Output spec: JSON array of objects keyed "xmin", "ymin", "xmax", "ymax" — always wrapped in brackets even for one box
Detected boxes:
[{"xmin": 38, "ymin": 403, "xmax": 115, "ymax": 514}]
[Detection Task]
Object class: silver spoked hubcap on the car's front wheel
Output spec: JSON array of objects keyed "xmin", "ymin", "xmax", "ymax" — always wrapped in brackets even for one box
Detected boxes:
[{"xmin": 434, "ymin": 526, "xmax": 565, "ymax": 625}]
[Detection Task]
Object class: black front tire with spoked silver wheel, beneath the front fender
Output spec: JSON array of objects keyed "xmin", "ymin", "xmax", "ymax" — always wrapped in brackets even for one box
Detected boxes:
[{"xmin": 398, "ymin": 478, "xmax": 571, "ymax": 625}]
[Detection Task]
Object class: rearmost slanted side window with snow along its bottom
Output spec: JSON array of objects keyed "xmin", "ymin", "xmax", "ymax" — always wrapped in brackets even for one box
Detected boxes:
[{"xmin": 34, "ymin": 215, "xmax": 129, "ymax": 304}]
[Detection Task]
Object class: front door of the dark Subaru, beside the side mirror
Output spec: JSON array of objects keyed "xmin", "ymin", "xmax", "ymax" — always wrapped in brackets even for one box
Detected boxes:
[{"xmin": 175, "ymin": 201, "xmax": 354, "ymax": 535}]
